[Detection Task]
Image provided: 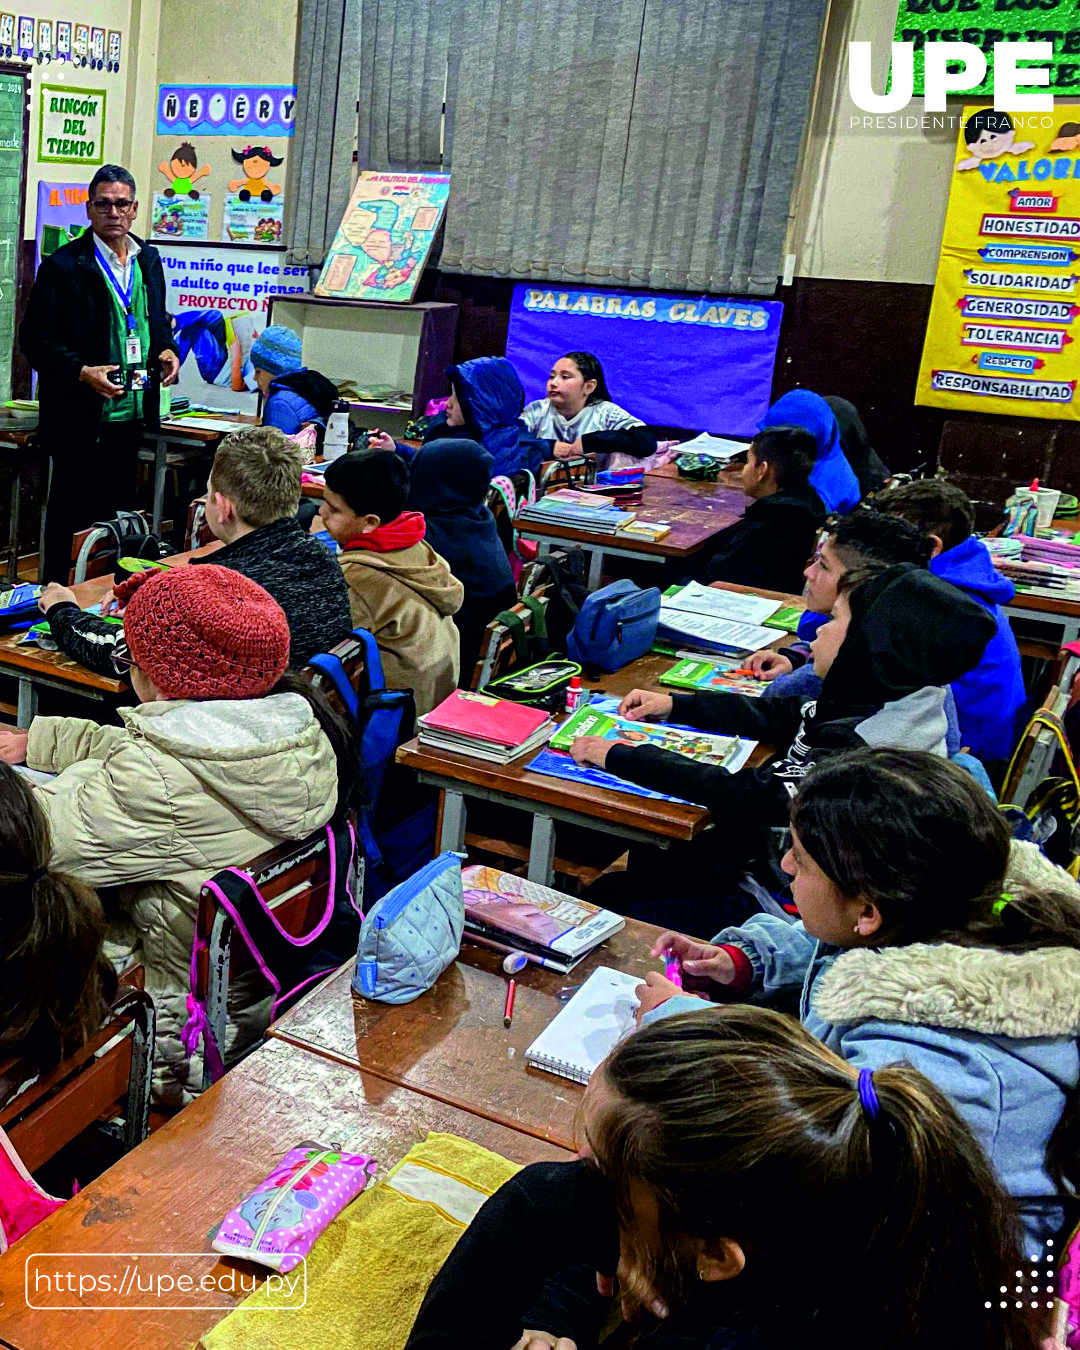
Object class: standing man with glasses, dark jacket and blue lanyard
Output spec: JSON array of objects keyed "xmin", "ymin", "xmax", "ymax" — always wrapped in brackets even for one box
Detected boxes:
[{"xmin": 19, "ymin": 165, "xmax": 180, "ymax": 585}]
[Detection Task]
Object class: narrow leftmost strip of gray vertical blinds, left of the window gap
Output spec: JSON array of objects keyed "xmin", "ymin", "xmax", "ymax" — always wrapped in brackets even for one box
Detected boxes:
[{"xmin": 284, "ymin": 0, "xmax": 360, "ymax": 266}]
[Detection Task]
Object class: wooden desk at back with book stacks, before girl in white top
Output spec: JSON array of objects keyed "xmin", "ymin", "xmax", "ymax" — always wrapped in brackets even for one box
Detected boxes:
[{"xmin": 514, "ymin": 466, "xmax": 749, "ymax": 590}]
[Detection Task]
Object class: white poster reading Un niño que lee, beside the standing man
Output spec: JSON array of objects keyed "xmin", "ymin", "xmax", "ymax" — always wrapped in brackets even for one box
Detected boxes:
[{"xmin": 154, "ymin": 240, "xmax": 311, "ymax": 413}]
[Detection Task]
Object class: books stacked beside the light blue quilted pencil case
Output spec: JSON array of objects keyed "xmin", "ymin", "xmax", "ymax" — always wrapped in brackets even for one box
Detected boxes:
[{"xmin": 462, "ymin": 867, "xmax": 625, "ymax": 975}]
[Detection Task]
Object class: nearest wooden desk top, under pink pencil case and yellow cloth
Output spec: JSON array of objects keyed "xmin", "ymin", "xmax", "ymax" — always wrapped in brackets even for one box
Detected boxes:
[{"xmin": 0, "ymin": 1036, "xmax": 570, "ymax": 1350}]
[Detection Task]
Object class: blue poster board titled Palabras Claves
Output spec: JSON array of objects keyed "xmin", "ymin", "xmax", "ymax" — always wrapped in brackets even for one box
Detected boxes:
[{"xmin": 506, "ymin": 282, "xmax": 784, "ymax": 436}]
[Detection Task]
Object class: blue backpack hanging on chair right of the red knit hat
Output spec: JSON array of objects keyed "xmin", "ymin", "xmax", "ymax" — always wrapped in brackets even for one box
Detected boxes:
[{"xmin": 309, "ymin": 628, "xmax": 436, "ymax": 906}]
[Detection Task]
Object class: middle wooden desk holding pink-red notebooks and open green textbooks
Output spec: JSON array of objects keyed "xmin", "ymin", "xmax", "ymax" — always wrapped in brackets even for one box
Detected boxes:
[{"xmin": 397, "ymin": 582, "xmax": 802, "ymax": 886}]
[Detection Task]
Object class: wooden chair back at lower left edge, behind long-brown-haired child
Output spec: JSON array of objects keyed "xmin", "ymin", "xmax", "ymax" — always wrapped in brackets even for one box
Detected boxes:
[{"xmin": 0, "ymin": 967, "xmax": 154, "ymax": 1172}]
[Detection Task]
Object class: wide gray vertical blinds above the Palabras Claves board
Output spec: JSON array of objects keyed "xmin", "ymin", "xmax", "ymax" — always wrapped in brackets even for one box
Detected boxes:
[{"xmin": 440, "ymin": 0, "xmax": 826, "ymax": 294}]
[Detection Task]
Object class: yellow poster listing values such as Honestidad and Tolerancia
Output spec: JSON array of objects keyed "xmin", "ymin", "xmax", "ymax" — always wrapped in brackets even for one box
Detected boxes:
[{"xmin": 915, "ymin": 104, "xmax": 1080, "ymax": 421}]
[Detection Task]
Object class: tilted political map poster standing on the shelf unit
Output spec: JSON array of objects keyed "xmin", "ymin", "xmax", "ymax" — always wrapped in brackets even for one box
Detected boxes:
[{"xmin": 315, "ymin": 169, "xmax": 450, "ymax": 305}]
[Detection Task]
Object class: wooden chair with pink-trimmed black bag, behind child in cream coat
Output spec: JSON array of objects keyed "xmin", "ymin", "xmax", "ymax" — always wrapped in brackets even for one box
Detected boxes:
[{"xmin": 185, "ymin": 817, "xmax": 363, "ymax": 1088}]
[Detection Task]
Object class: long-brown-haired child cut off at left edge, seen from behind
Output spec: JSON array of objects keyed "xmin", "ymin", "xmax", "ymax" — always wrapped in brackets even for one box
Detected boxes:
[{"xmin": 0, "ymin": 764, "xmax": 116, "ymax": 1100}]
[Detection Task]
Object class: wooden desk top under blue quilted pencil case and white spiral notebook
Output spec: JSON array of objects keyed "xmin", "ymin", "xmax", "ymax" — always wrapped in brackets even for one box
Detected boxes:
[{"xmin": 270, "ymin": 919, "xmax": 662, "ymax": 1149}]
